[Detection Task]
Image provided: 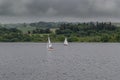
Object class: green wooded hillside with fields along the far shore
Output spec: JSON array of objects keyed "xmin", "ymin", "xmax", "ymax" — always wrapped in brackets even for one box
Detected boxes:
[{"xmin": 0, "ymin": 22, "xmax": 120, "ymax": 42}]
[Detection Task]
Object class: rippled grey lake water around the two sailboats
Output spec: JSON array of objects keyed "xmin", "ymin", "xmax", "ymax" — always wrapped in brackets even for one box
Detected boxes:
[{"xmin": 0, "ymin": 43, "xmax": 120, "ymax": 80}]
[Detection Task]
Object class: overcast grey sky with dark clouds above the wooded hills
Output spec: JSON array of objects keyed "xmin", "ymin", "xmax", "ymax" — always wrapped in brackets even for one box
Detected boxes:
[{"xmin": 0, "ymin": 0, "xmax": 120, "ymax": 23}]
